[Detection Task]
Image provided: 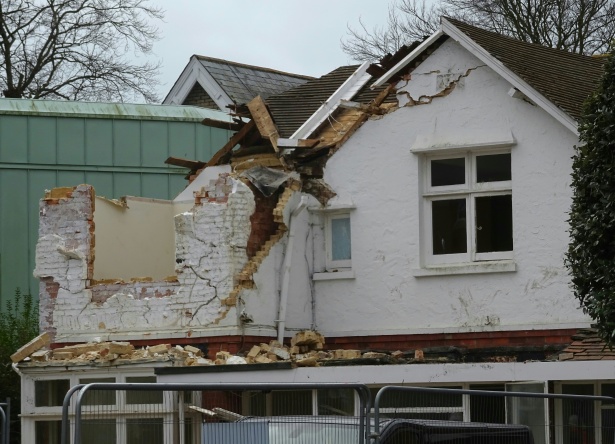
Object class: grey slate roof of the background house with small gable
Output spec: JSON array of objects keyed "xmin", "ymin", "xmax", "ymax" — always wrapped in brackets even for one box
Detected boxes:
[{"xmin": 196, "ymin": 56, "xmax": 313, "ymax": 104}]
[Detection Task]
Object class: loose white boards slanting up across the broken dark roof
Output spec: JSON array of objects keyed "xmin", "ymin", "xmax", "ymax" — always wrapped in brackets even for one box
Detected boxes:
[{"xmin": 290, "ymin": 62, "xmax": 371, "ymax": 139}]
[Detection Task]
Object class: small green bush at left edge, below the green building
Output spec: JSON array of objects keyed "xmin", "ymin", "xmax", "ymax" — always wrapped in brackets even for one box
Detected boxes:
[{"xmin": 0, "ymin": 289, "xmax": 38, "ymax": 442}]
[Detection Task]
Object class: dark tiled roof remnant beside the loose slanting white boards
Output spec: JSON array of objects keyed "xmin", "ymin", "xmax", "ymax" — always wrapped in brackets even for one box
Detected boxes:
[{"xmin": 267, "ymin": 65, "xmax": 392, "ymax": 137}]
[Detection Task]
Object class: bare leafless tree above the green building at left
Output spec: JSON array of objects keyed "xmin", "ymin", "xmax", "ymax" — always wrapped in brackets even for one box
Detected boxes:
[{"xmin": 0, "ymin": 0, "xmax": 163, "ymax": 102}]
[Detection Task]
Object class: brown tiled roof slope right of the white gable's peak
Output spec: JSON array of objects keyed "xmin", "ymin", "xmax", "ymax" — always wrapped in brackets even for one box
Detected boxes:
[{"xmin": 446, "ymin": 18, "xmax": 604, "ymax": 120}]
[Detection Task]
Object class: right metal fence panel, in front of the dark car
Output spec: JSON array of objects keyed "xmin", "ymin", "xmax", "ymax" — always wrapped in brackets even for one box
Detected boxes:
[{"xmin": 372, "ymin": 382, "xmax": 615, "ymax": 444}]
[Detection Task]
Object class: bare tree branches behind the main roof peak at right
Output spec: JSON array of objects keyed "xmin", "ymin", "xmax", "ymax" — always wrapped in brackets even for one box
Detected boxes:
[{"xmin": 341, "ymin": 0, "xmax": 615, "ymax": 61}]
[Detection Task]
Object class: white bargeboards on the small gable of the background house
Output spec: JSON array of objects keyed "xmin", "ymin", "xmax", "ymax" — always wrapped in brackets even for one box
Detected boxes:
[{"xmin": 162, "ymin": 56, "xmax": 233, "ymax": 112}]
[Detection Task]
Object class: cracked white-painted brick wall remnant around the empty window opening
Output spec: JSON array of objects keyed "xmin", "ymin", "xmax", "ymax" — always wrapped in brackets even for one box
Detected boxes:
[{"xmin": 35, "ymin": 175, "xmax": 255, "ymax": 342}]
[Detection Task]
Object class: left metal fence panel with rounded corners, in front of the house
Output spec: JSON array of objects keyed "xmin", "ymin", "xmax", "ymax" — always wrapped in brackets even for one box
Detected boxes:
[{"xmin": 60, "ymin": 380, "xmax": 371, "ymax": 444}]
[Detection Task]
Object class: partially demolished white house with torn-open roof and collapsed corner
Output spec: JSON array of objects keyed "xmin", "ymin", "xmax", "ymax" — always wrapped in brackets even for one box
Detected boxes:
[{"xmin": 17, "ymin": 18, "xmax": 615, "ymax": 443}]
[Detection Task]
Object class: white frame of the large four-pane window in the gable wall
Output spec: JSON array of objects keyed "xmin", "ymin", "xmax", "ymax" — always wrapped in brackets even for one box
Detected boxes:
[{"xmin": 421, "ymin": 149, "xmax": 514, "ymax": 266}]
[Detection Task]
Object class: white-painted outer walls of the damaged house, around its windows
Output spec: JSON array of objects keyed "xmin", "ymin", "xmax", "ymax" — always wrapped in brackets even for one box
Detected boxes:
[{"xmin": 36, "ymin": 39, "xmax": 590, "ymax": 341}]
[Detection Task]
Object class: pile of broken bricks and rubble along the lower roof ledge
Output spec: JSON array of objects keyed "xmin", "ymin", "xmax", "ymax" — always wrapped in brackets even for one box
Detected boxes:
[{"xmin": 11, "ymin": 330, "xmax": 434, "ymax": 367}]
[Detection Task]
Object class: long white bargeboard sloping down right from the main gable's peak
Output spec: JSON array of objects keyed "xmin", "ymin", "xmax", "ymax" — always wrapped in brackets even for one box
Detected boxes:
[{"xmin": 441, "ymin": 18, "xmax": 579, "ymax": 135}]
